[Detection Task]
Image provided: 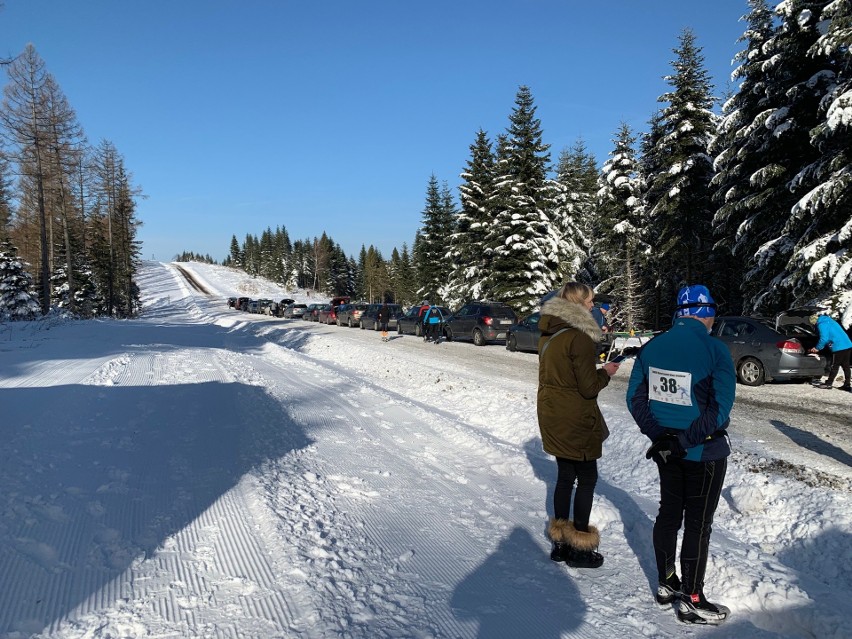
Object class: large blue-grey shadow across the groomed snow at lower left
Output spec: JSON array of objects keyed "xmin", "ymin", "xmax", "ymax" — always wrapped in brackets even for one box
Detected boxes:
[{"xmin": 0, "ymin": 383, "xmax": 310, "ymax": 636}]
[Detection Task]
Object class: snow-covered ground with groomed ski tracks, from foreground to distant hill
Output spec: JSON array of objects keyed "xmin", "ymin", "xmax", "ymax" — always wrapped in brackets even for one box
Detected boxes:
[{"xmin": 0, "ymin": 262, "xmax": 852, "ymax": 639}]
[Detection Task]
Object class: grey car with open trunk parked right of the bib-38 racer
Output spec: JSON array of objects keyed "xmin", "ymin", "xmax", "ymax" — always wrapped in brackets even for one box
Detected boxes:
[{"xmin": 710, "ymin": 316, "xmax": 826, "ymax": 386}]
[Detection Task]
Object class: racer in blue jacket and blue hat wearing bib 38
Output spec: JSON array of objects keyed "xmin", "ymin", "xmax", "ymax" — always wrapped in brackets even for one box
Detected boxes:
[{"xmin": 627, "ymin": 284, "xmax": 736, "ymax": 625}]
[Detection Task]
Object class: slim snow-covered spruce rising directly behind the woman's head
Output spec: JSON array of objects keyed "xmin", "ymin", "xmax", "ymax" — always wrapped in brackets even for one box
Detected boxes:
[{"xmin": 550, "ymin": 140, "xmax": 598, "ymax": 286}]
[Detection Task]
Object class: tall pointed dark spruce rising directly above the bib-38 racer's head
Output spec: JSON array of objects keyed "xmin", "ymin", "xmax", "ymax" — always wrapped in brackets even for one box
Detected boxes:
[{"xmin": 646, "ymin": 29, "xmax": 716, "ymax": 324}]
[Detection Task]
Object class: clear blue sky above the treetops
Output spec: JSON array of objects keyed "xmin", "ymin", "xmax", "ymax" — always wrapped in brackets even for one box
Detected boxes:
[{"xmin": 0, "ymin": 0, "xmax": 748, "ymax": 260}]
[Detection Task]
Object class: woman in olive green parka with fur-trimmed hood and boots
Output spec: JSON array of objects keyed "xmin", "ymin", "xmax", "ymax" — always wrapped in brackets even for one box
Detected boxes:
[{"xmin": 537, "ymin": 282, "xmax": 618, "ymax": 568}]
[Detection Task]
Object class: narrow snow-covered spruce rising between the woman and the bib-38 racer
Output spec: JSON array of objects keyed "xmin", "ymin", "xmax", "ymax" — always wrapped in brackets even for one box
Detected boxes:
[{"xmin": 594, "ymin": 122, "xmax": 650, "ymax": 330}]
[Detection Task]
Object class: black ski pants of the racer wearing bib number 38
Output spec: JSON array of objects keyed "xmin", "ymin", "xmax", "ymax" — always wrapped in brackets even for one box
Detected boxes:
[{"xmin": 654, "ymin": 459, "xmax": 728, "ymax": 594}]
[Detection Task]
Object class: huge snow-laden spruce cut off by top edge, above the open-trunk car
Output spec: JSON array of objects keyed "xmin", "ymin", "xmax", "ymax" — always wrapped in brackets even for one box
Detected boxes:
[{"xmin": 724, "ymin": 0, "xmax": 828, "ymax": 314}]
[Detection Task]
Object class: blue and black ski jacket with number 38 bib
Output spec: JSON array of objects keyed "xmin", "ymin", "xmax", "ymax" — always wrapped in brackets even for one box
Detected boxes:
[{"xmin": 627, "ymin": 317, "xmax": 737, "ymax": 461}]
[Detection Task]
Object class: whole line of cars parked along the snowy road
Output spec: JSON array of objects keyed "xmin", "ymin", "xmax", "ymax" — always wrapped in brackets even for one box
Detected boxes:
[{"xmin": 228, "ymin": 297, "xmax": 828, "ymax": 386}]
